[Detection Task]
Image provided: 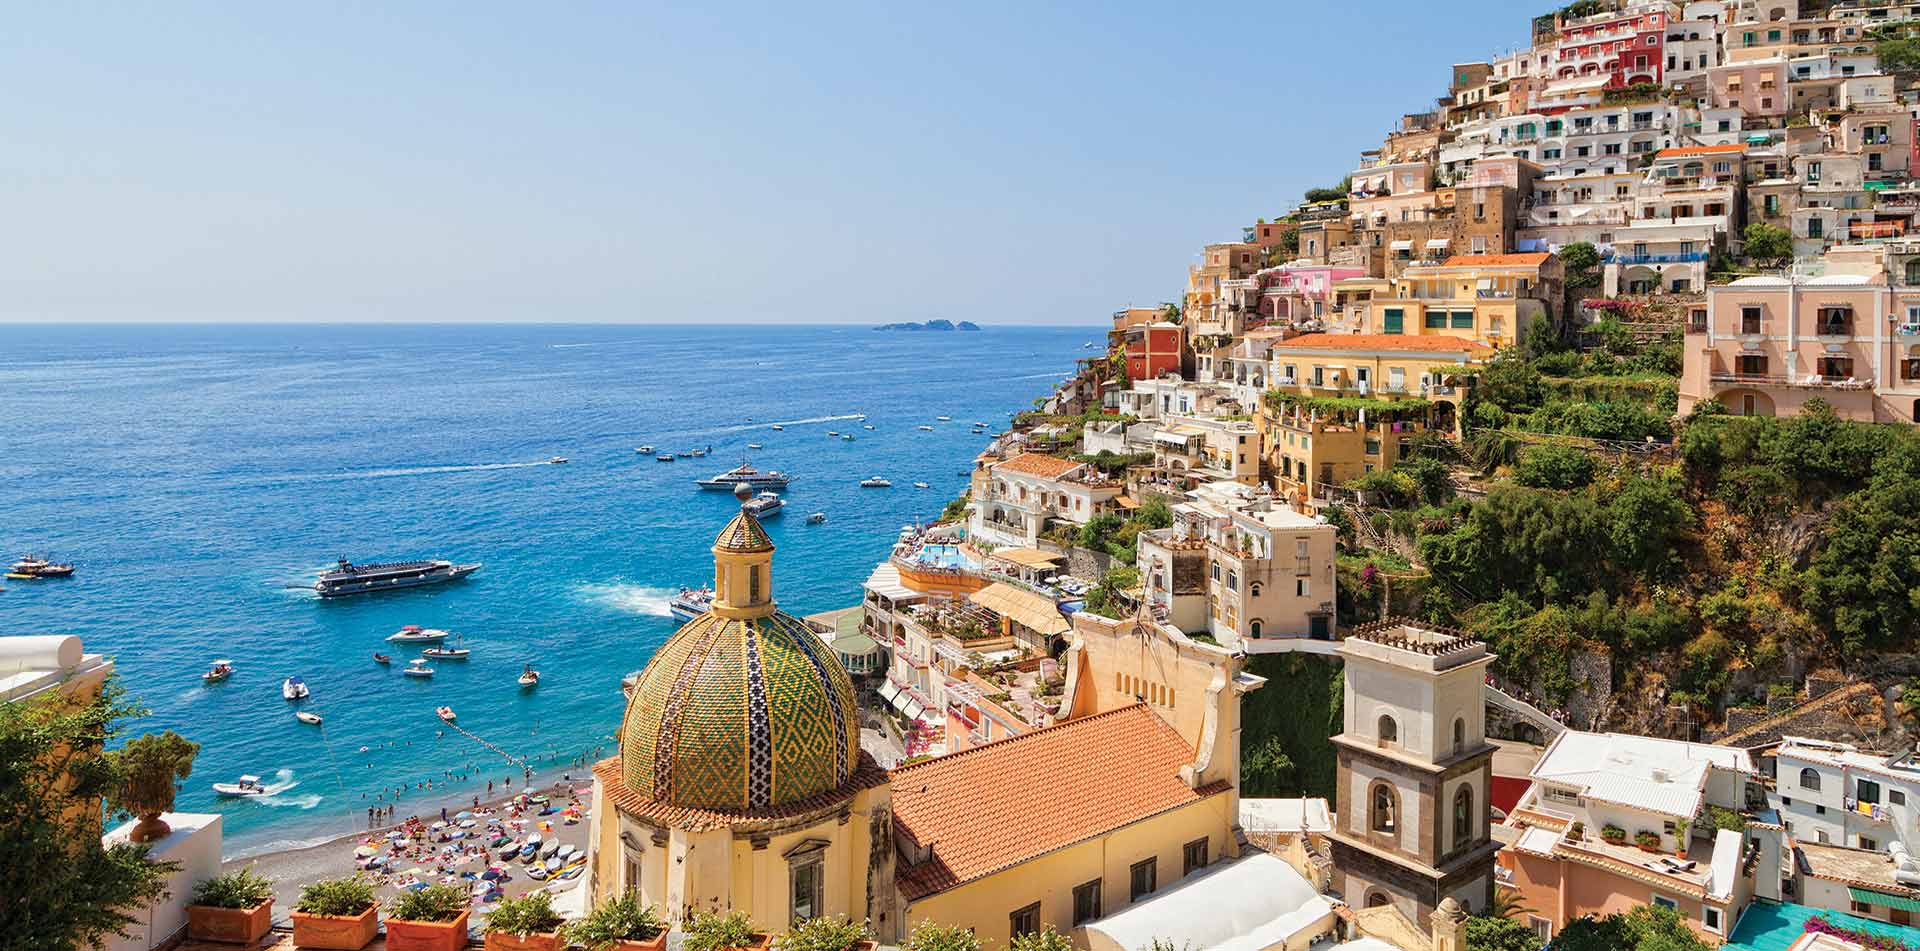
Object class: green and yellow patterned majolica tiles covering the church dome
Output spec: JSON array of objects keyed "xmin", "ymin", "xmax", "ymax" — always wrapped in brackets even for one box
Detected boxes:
[{"xmin": 620, "ymin": 613, "xmax": 860, "ymax": 813}]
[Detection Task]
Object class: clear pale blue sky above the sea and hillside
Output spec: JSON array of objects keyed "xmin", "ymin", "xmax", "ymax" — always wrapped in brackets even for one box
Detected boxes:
[{"xmin": 0, "ymin": 2, "xmax": 1544, "ymax": 325}]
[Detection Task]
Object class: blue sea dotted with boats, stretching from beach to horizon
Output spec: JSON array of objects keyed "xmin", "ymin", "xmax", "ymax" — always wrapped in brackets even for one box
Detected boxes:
[{"xmin": 0, "ymin": 325, "xmax": 1100, "ymax": 855}]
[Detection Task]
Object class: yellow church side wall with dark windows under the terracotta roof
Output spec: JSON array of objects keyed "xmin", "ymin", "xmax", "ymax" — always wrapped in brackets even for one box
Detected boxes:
[{"xmin": 902, "ymin": 795, "xmax": 1233, "ymax": 949}]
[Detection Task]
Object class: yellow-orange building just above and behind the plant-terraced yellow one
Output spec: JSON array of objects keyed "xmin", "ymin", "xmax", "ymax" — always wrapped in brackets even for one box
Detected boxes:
[{"xmin": 1361, "ymin": 252, "xmax": 1561, "ymax": 348}]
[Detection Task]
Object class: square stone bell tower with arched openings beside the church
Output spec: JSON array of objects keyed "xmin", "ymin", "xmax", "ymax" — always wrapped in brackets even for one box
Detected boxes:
[{"xmin": 1331, "ymin": 621, "xmax": 1498, "ymax": 924}]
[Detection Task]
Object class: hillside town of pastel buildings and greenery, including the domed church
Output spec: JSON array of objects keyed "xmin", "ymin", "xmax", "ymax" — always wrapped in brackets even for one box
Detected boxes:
[{"xmin": 30, "ymin": 0, "xmax": 1920, "ymax": 951}]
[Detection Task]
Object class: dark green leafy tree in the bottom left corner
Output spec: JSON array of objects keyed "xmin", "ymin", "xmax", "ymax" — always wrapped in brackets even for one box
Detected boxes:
[{"xmin": 0, "ymin": 682, "xmax": 179, "ymax": 951}]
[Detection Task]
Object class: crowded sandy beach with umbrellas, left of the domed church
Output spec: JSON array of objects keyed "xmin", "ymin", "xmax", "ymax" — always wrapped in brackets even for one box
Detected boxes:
[{"xmin": 223, "ymin": 778, "xmax": 593, "ymax": 918}]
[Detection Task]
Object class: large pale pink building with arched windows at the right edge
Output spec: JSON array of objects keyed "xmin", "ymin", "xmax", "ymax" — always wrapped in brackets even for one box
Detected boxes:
[{"xmin": 1678, "ymin": 242, "xmax": 1920, "ymax": 423}]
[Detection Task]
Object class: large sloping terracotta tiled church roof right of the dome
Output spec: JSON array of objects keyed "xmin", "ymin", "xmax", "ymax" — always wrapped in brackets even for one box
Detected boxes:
[{"xmin": 893, "ymin": 703, "xmax": 1231, "ymax": 901}]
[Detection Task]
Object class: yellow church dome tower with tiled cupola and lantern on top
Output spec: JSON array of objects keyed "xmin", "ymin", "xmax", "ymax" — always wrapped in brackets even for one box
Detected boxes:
[{"xmin": 589, "ymin": 499, "xmax": 893, "ymax": 938}]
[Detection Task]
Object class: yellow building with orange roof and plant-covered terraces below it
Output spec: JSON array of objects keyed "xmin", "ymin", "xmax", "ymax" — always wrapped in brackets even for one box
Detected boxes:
[{"xmin": 1258, "ymin": 336, "xmax": 1492, "ymax": 511}]
